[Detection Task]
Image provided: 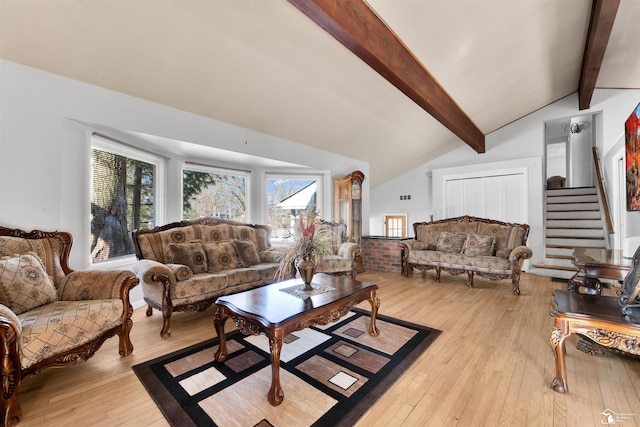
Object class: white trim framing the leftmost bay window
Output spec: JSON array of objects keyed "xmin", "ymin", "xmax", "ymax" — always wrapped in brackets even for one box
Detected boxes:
[{"xmin": 90, "ymin": 134, "xmax": 166, "ymax": 270}]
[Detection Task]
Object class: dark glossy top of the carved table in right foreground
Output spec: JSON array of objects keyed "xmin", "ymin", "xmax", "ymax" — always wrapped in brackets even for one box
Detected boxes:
[{"xmin": 551, "ymin": 289, "xmax": 640, "ymax": 331}]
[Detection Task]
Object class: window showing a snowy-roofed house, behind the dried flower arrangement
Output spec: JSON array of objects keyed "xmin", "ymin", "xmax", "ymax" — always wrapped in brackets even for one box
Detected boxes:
[{"xmin": 266, "ymin": 175, "xmax": 322, "ymax": 243}]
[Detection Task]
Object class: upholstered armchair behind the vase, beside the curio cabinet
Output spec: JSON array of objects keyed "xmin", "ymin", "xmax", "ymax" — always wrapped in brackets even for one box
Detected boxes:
[{"xmin": 316, "ymin": 221, "xmax": 362, "ymax": 280}]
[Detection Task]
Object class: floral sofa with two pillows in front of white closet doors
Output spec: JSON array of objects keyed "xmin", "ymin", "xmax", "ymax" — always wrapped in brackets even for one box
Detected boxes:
[{"xmin": 400, "ymin": 216, "xmax": 532, "ymax": 295}]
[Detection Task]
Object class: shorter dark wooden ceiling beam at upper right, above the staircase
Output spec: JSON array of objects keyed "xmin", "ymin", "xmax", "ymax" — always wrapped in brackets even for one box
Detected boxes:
[{"xmin": 578, "ymin": 0, "xmax": 620, "ymax": 110}]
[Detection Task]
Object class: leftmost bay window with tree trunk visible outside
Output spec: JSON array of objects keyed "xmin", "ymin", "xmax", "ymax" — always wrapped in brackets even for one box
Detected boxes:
[{"xmin": 90, "ymin": 135, "xmax": 162, "ymax": 264}]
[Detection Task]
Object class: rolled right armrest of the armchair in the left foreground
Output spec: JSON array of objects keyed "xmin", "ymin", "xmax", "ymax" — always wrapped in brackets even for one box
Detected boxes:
[{"xmin": 58, "ymin": 270, "xmax": 138, "ymax": 301}]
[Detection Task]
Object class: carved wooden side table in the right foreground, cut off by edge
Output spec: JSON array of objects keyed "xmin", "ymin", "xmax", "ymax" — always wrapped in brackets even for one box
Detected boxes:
[{"xmin": 549, "ymin": 290, "xmax": 640, "ymax": 393}]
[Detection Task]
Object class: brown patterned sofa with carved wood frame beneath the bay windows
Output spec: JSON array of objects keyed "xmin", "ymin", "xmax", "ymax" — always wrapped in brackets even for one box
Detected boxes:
[{"xmin": 132, "ymin": 217, "xmax": 293, "ymax": 337}]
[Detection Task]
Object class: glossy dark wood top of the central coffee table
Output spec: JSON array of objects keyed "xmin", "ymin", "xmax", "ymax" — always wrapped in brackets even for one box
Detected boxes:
[{"xmin": 216, "ymin": 273, "xmax": 378, "ymax": 327}]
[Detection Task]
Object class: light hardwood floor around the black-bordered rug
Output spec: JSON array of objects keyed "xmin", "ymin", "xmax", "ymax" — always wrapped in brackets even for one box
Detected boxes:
[{"xmin": 13, "ymin": 272, "xmax": 640, "ymax": 427}]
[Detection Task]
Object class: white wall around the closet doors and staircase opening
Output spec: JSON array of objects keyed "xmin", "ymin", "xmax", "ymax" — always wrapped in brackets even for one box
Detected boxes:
[{"xmin": 370, "ymin": 89, "xmax": 640, "ymax": 270}]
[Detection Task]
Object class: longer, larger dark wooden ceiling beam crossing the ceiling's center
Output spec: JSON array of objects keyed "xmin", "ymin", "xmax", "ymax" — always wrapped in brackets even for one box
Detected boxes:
[{"xmin": 288, "ymin": 0, "xmax": 485, "ymax": 153}]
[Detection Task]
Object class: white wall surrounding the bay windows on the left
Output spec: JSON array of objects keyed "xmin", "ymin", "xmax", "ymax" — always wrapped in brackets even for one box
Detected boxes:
[{"xmin": 0, "ymin": 60, "xmax": 370, "ymax": 306}]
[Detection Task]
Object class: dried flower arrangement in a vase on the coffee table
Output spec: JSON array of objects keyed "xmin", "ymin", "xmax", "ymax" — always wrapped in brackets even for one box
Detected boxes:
[{"xmin": 276, "ymin": 205, "xmax": 331, "ymax": 291}]
